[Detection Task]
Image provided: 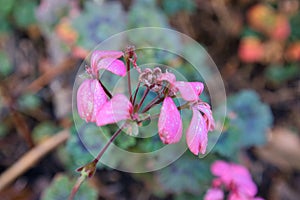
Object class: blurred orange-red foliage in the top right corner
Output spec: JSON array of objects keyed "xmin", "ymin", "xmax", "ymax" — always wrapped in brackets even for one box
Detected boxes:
[{"xmin": 238, "ymin": 3, "xmax": 300, "ymax": 84}]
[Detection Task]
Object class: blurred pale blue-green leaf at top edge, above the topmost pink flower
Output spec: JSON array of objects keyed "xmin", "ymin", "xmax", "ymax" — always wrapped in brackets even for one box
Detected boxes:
[{"xmin": 72, "ymin": 1, "xmax": 126, "ymax": 49}]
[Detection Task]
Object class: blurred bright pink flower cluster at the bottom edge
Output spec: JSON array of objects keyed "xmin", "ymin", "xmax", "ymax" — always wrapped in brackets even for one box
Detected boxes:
[{"xmin": 204, "ymin": 160, "xmax": 263, "ymax": 200}]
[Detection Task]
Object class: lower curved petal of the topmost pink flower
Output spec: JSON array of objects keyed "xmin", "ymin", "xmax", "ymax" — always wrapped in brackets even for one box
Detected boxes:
[{"xmin": 96, "ymin": 58, "xmax": 126, "ymax": 76}]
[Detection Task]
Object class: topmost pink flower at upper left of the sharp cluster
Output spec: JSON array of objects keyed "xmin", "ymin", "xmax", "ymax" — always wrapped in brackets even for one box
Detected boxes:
[{"xmin": 91, "ymin": 50, "xmax": 126, "ymax": 77}]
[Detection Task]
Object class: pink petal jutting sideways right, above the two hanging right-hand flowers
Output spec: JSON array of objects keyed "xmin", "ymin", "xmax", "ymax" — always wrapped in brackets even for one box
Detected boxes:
[{"xmin": 174, "ymin": 81, "xmax": 204, "ymax": 101}]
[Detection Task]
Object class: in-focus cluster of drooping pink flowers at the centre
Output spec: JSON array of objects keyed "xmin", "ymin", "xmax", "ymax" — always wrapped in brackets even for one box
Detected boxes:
[{"xmin": 77, "ymin": 47, "xmax": 214, "ymax": 155}]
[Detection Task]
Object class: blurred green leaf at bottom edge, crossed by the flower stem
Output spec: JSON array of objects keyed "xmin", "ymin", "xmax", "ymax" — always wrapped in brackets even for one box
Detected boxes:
[{"xmin": 42, "ymin": 174, "xmax": 98, "ymax": 200}]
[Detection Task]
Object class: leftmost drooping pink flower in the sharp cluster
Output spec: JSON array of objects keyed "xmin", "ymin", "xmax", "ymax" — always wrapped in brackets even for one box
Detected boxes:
[{"xmin": 77, "ymin": 79, "xmax": 107, "ymax": 122}]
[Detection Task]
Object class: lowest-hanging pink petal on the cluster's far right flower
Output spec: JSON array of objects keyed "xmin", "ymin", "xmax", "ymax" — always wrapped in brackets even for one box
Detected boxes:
[{"xmin": 186, "ymin": 109, "xmax": 208, "ymax": 155}]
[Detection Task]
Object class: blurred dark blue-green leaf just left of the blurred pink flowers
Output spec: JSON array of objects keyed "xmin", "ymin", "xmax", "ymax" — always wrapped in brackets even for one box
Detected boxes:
[{"xmin": 156, "ymin": 155, "xmax": 212, "ymax": 194}]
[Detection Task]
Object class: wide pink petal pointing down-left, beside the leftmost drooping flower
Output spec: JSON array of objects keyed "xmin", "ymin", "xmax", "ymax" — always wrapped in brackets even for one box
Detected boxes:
[{"xmin": 96, "ymin": 94, "xmax": 132, "ymax": 126}]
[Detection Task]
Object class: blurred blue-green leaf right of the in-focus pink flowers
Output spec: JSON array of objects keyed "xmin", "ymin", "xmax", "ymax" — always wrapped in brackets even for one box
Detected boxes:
[{"xmin": 213, "ymin": 90, "xmax": 273, "ymax": 159}]
